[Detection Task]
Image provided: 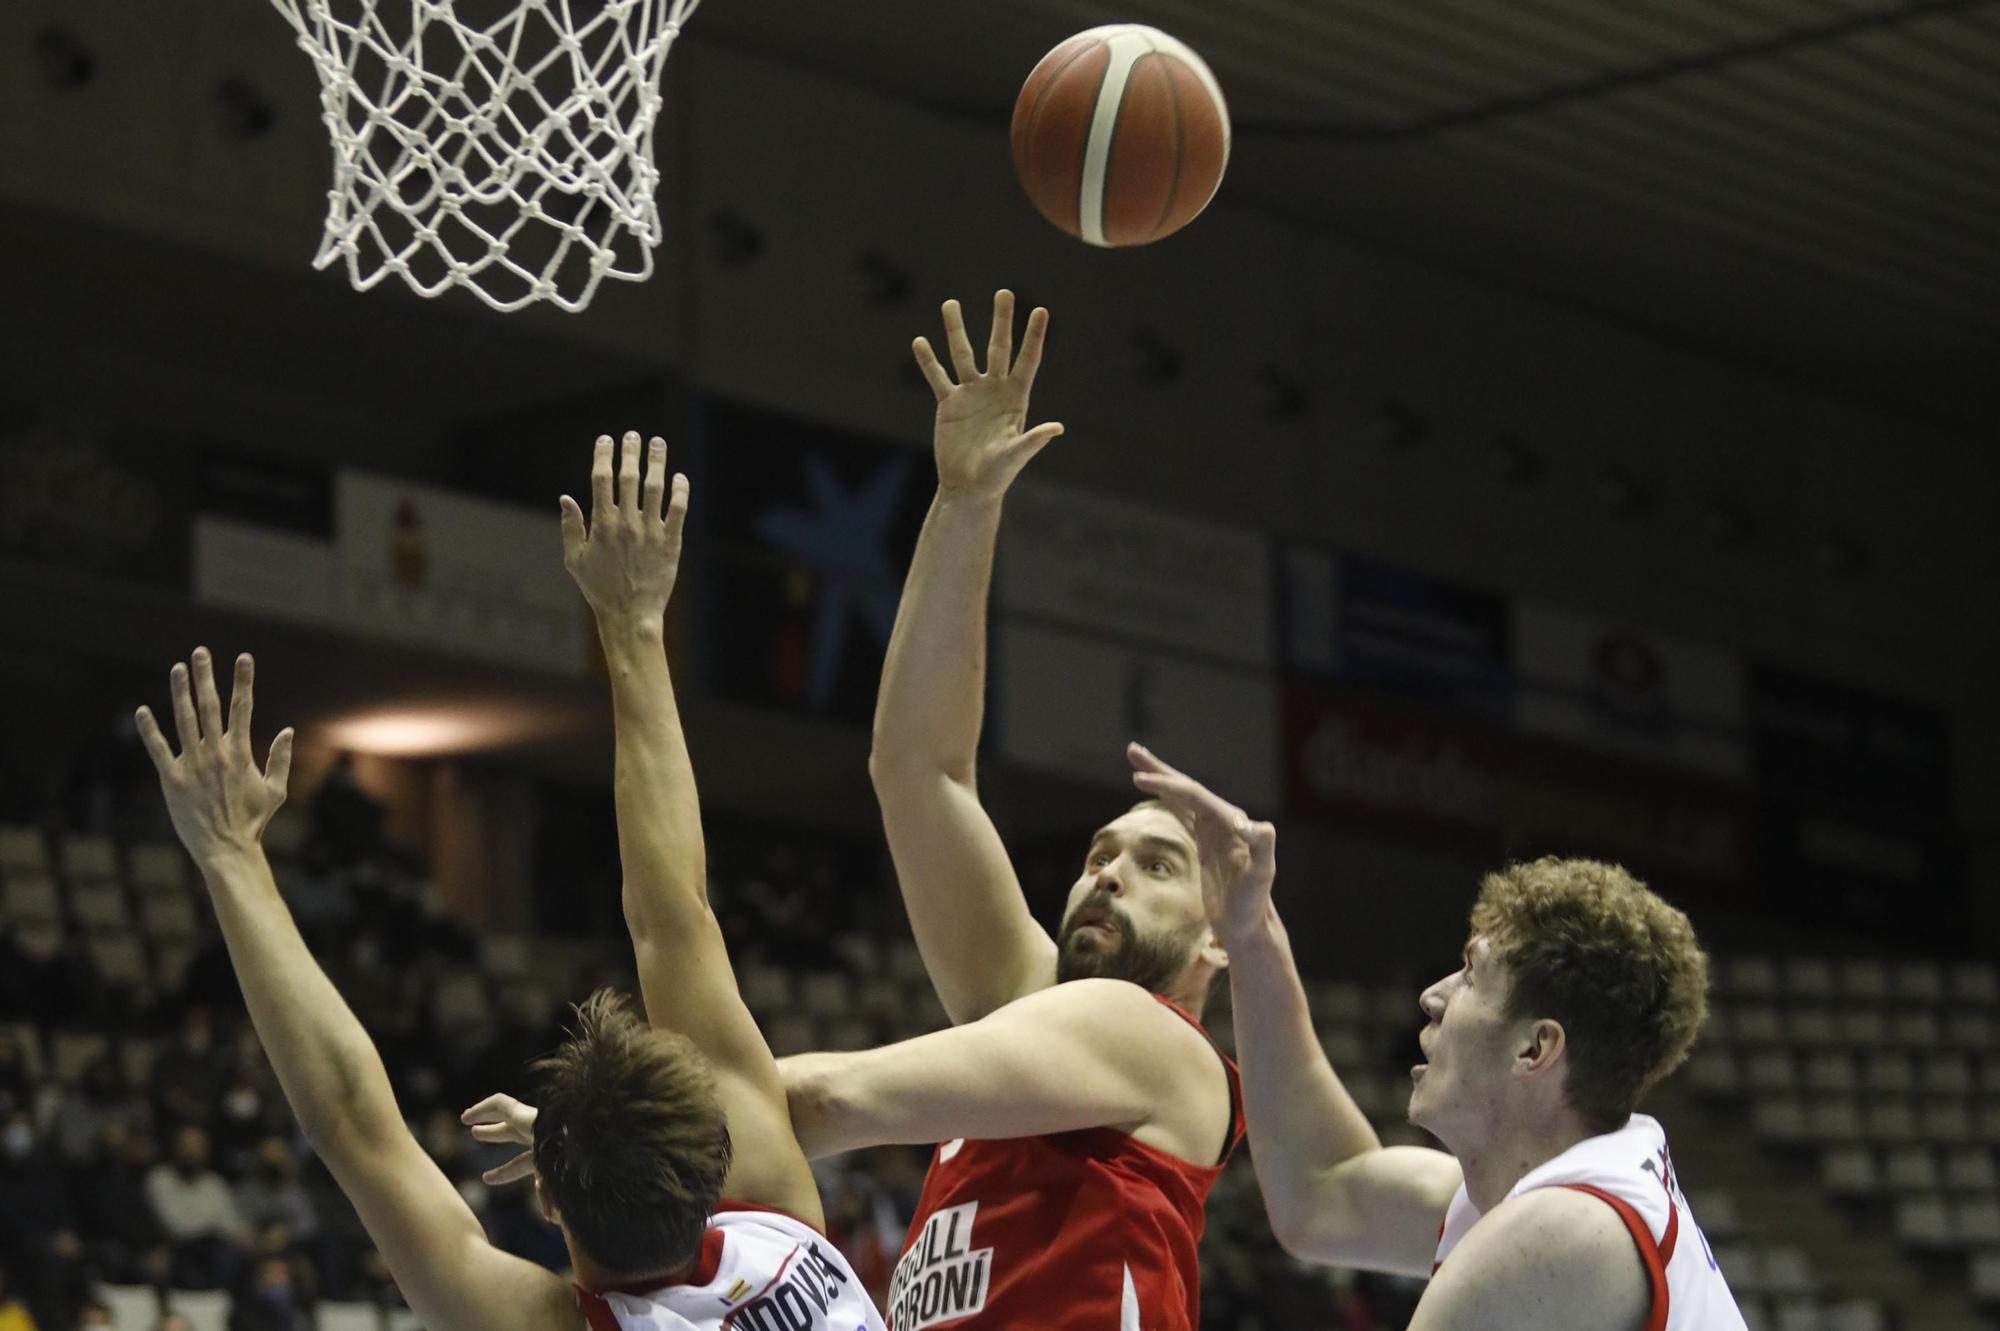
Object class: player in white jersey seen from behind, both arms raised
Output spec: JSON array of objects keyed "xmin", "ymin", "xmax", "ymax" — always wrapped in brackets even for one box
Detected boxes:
[{"xmin": 138, "ymin": 434, "xmax": 882, "ymax": 1331}]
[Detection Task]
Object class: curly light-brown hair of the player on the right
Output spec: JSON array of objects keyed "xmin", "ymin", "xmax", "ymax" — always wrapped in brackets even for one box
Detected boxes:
[{"xmin": 1472, "ymin": 855, "xmax": 1708, "ymax": 1133}]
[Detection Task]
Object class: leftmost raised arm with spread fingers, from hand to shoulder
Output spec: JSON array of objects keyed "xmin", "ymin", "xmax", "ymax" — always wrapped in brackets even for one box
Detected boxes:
[{"xmin": 138, "ymin": 648, "xmax": 584, "ymax": 1331}]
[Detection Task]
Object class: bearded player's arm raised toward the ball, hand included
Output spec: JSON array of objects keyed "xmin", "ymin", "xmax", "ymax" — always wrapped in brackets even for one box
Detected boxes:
[{"xmin": 868, "ymin": 292, "xmax": 1062, "ymax": 1021}]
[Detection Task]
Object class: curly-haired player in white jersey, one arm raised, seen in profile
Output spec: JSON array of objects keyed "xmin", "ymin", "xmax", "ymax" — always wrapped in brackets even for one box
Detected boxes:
[{"xmin": 1132, "ymin": 747, "xmax": 1744, "ymax": 1331}]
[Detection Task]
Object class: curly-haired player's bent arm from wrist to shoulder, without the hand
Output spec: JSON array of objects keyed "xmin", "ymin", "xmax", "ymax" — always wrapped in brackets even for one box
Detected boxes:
[{"xmin": 1228, "ymin": 909, "xmax": 1462, "ymax": 1275}]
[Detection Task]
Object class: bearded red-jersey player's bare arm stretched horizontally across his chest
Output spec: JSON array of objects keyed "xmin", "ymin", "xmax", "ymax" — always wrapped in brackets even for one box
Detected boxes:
[{"xmin": 782, "ymin": 979, "xmax": 1186, "ymax": 1159}]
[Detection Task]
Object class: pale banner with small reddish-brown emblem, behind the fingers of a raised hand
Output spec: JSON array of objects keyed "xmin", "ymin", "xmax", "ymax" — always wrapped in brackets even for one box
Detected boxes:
[{"xmin": 334, "ymin": 472, "xmax": 586, "ymax": 673}]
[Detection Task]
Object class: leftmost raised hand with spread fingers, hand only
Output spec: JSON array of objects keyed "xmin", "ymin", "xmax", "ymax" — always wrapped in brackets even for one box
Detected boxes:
[{"xmin": 136, "ymin": 648, "xmax": 292, "ymax": 863}]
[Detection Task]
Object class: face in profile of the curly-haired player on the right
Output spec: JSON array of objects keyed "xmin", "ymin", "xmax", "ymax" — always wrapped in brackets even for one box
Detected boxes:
[{"xmin": 1410, "ymin": 935, "xmax": 1522, "ymax": 1143}]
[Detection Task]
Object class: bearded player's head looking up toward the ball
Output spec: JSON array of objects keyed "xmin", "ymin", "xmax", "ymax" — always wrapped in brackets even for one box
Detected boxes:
[{"xmin": 1056, "ymin": 805, "xmax": 1208, "ymax": 991}]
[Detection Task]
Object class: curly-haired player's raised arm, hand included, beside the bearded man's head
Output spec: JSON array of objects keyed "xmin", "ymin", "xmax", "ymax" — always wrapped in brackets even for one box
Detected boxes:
[{"xmin": 1128, "ymin": 743, "xmax": 1462, "ymax": 1275}]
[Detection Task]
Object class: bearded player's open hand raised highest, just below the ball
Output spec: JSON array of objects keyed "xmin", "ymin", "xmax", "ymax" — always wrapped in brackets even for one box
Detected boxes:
[{"xmin": 910, "ymin": 290, "xmax": 1062, "ymax": 500}]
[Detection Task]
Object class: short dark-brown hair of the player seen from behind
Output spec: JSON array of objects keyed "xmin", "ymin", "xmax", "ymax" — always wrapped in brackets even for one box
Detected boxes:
[{"xmin": 534, "ymin": 989, "xmax": 730, "ymax": 1275}]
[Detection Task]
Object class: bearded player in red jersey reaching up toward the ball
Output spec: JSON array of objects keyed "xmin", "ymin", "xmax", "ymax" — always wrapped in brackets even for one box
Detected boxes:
[{"xmin": 786, "ymin": 292, "xmax": 1240, "ymax": 1331}]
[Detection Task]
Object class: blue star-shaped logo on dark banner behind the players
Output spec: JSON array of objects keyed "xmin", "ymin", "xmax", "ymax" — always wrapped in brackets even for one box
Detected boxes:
[{"xmin": 756, "ymin": 458, "xmax": 910, "ymax": 707}]
